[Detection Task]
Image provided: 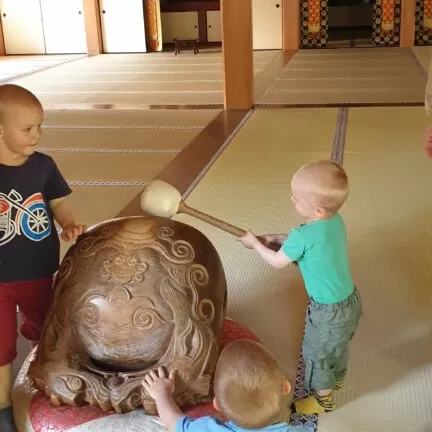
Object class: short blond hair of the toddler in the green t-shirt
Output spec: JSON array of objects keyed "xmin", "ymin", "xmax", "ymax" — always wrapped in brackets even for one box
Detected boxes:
[{"xmin": 293, "ymin": 160, "xmax": 349, "ymax": 212}]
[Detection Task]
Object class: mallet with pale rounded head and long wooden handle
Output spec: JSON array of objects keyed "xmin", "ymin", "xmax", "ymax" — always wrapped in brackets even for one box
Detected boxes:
[{"xmin": 141, "ymin": 180, "xmax": 280, "ymax": 250}]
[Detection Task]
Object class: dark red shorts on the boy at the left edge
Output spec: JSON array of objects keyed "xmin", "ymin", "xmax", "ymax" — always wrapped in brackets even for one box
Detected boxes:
[{"xmin": 0, "ymin": 277, "xmax": 53, "ymax": 366}]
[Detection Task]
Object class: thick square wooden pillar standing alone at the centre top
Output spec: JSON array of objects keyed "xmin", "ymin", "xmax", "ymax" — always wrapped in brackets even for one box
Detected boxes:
[{"xmin": 221, "ymin": 0, "xmax": 254, "ymax": 109}]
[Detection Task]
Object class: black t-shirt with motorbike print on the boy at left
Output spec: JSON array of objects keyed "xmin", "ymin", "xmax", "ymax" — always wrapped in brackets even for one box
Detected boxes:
[{"xmin": 0, "ymin": 152, "xmax": 72, "ymax": 282}]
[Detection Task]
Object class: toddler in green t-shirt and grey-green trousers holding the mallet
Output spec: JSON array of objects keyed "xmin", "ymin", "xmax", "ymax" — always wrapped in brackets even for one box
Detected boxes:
[{"xmin": 240, "ymin": 160, "xmax": 361, "ymax": 414}]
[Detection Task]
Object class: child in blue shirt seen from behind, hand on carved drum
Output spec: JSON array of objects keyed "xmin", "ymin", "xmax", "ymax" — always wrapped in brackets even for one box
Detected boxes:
[{"xmin": 143, "ymin": 340, "xmax": 312, "ymax": 432}]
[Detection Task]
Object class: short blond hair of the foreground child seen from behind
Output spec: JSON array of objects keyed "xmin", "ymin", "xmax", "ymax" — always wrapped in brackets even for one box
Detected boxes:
[{"xmin": 214, "ymin": 340, "xmax": 285, "ymax": 429}]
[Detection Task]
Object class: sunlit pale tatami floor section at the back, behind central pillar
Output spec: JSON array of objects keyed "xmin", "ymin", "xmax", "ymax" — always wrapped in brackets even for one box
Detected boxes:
[{"xmin": 10, "ymin": 51, "xmax": 278, "ymax": 108}]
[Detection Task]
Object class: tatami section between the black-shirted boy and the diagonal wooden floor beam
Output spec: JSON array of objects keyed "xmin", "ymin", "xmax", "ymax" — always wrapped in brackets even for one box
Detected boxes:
[{"xmin": 39, "ymin": 110, "xmax": 219, "ymax": 253}]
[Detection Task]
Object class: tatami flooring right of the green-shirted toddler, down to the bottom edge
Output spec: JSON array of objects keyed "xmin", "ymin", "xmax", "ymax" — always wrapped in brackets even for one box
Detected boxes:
[{"xmin": 319, "ymin": 108, "xmax": 432, "ymax": 432}]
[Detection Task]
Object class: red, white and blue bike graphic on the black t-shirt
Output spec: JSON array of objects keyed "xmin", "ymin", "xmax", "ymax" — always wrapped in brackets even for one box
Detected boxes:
[{"xmin": 0, "ymin": 189, "xmax": 51, "ymax": 246}]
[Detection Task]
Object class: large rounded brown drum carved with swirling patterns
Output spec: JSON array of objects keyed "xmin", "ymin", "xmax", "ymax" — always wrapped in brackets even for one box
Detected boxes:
[{"xmin": 29, "ymin": 216, "xmax": 226, "ymax": 414}]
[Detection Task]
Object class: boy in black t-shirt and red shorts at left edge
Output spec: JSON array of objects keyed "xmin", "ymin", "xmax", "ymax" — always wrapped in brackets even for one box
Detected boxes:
[{"xmin": 0, "ymin": 84, "xmax": 84, "ymax": 432}]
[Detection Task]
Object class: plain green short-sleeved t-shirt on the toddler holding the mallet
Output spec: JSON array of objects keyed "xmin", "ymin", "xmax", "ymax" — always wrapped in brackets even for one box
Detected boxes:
[{"xmin": 282, "ymin": 213, "xmax": 354, "ymax": 304}]
